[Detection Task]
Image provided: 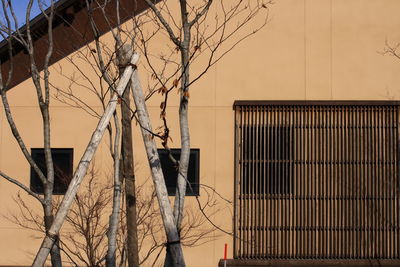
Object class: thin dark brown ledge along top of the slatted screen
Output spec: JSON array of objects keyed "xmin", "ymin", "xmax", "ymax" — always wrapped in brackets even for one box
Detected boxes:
[{"xmin": 233, "ymin": 100, "xmax": 400, "ymax": 109}]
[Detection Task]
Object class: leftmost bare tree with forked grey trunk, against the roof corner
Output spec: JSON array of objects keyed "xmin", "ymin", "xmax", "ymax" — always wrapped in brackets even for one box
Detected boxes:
[{"xmin": 0, "ymin": 0, "xmax": 61, "ymax": 266}]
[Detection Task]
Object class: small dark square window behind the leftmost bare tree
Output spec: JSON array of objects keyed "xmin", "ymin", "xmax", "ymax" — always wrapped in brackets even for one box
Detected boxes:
[{"xmin": 31, "ymin": 148, "xmax": 74, "ymax": 195}]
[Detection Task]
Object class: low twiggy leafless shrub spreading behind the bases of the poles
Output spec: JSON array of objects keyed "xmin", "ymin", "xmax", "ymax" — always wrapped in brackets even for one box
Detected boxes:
[{"xmin": 6, "ymin": 163, "xmax": 218, "ymax": 267}]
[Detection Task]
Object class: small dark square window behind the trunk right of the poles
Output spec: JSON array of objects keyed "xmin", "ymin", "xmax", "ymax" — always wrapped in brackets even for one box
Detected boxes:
[{"xmin": 158, "ymin": 149, "xmax": 200, "ymax": 196}]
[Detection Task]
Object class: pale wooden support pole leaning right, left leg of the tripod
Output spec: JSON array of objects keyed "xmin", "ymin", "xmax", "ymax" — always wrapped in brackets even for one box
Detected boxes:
[{"xmin": 32, "ymin": 54, "xmax": 139, "ymax": 267}]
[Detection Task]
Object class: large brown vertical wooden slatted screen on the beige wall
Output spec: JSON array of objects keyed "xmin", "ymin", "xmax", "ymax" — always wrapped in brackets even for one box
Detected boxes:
[{"xmin": 234, "ymin": 101, "xmax": 400, "ymax": 259}]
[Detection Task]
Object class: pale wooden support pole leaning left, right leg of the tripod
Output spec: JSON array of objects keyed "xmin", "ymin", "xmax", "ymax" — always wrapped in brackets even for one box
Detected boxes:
[{"xmin": 131, "ymin": 63, "xmax": 186, "ymax": 267}]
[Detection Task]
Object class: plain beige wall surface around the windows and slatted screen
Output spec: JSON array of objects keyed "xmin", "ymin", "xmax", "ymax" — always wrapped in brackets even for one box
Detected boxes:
[{"xmin": 0, "ymin": 0, "xmax": 400, "ymax": 266}]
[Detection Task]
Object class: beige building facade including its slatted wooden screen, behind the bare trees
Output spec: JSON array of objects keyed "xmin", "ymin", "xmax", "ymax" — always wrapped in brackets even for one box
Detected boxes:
[{"xmin": 0, "ymin": 0, "xmax": 400, "ymax": 266}]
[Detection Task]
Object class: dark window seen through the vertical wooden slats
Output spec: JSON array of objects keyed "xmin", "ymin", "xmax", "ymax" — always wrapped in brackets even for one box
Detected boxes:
[{"xmin": 242, "ymin": 125, "xmax": 293, "ymax": 194}]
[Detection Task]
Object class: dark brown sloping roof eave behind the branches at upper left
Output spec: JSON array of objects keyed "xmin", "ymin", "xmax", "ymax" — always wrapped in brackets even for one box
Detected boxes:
[{"xmin": 0, "ymin": 0, "xmax": 155, "ymax": 89}]
